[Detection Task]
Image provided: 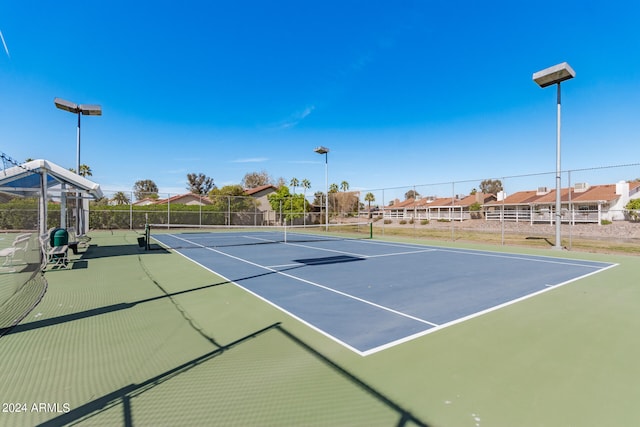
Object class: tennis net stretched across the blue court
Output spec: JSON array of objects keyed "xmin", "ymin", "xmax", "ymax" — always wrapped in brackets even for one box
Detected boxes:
[{"xmin": 147, "ymin": 222, "xmax": 373, "ymax": 249}]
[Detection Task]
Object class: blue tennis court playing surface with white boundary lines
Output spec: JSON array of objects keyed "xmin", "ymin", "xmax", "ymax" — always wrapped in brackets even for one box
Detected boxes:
[{"xmin": 153, "ymin": 233, "xmax": 616, "ymax": 356}]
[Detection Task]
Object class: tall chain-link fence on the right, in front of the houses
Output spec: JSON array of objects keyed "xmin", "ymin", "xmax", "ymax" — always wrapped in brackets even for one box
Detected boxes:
[{"xmin": 359, "ymin": 163, "xmax": 640, "ymax": 252}]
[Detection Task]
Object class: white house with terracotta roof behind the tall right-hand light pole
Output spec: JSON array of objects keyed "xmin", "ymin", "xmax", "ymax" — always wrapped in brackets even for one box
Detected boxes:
[{"xmin": 484, "ymin": 181, "xmax": 640, "ymax": 224}]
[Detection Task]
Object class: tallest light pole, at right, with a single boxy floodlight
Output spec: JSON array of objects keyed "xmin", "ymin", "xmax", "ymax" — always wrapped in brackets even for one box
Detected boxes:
[{"xmin": 533, "ymin": 62, "xmax": 576, "ymax": 249}]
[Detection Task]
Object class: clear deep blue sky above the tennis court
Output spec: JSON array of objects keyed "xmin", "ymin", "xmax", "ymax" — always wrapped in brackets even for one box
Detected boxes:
[{"xmin": 0, "ymin": 0, "xmax": 640, "ymax": 201}]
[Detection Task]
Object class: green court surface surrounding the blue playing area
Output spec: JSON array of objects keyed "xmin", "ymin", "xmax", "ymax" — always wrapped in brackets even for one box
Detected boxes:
[{"xmin": 0, "ymin": 231, "xmax": 640, "ymax": 427}]
